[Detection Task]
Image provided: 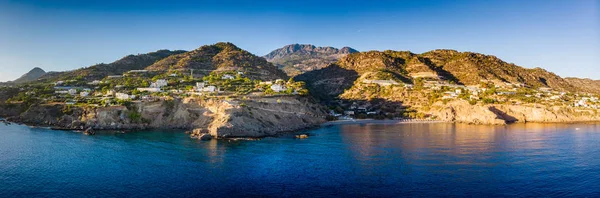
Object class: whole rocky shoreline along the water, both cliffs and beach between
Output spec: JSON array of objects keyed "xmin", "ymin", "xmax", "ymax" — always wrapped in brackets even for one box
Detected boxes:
[{"xmin": 0, "ymin": 97, "xmax": 600, "ymax": 140}]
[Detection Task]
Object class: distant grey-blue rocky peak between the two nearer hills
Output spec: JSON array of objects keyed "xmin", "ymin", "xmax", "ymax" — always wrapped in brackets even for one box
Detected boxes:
[{"xmin": 264, "ymin": 44, "xmax": 358, "ymax": 76}]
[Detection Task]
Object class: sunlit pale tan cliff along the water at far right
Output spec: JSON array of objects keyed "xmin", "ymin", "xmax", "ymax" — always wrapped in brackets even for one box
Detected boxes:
[{"xmin": 429, "ymin": 101, "xmax": 600, "ymax": 124}]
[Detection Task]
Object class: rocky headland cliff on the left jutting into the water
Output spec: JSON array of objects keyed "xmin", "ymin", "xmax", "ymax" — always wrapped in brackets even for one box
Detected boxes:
[{"xmin": 4, "ymin": 96, "xmax": 325, "ymax": 137}]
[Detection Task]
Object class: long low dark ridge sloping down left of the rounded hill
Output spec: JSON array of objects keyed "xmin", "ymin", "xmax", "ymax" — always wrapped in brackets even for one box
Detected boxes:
[{"xmin": 40, "ymin": 50, "xmax": 185, "ymax": 82}]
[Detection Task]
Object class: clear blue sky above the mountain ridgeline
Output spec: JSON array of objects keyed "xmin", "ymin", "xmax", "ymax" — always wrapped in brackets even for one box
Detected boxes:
[{"xmin": 0, "ymin": 0, "xmax": 600, "ymax": 81}]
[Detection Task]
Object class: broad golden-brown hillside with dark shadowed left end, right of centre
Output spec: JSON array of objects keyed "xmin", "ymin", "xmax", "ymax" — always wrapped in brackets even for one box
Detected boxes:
[{"xmin": 297, "ymin": 50, "xmax": 578, "ymax": 96}]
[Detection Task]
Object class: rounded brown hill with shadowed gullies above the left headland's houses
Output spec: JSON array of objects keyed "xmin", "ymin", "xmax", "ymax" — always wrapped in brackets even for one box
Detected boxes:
[{"xmin": 146, "ymin": 43, "xmax": 287, "ymax": 80}]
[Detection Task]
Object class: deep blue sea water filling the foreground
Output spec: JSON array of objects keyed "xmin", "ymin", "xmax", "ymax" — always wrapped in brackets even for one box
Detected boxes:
[{"xmin": 0, "ymin": 124, "xmax": 600, "ymax": 197}]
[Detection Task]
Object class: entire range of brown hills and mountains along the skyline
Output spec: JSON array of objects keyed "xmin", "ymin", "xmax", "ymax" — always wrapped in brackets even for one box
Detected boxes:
[{"xmin": 2, "ymin": 42, "xmax": 600, "ymax": 95}]
